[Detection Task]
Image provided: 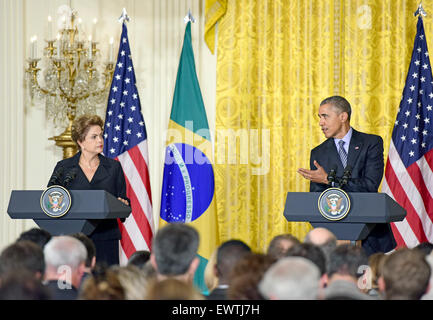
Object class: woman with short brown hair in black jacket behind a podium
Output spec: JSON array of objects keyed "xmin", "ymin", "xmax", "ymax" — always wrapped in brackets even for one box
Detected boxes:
[{"xmin": 48, "ymin": 115, "xmax": 129, "ymax": 265}]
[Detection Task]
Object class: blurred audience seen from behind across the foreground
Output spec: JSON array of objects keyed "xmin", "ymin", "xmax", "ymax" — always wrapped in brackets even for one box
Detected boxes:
[{"xmin": 0, "ymin": 224, "xmax": 433, "ymax": 300}]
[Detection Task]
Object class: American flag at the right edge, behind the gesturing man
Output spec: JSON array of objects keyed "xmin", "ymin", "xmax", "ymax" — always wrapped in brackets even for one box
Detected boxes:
[{"xmin": 382, "ymin": 17, "xmax": 433, "ymax": 248}]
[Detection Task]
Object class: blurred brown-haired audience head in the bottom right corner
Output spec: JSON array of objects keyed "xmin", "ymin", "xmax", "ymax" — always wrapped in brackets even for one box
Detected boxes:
[{"xmin": 382, "ymin": 248, "xmax": 431, "ymax": 300}]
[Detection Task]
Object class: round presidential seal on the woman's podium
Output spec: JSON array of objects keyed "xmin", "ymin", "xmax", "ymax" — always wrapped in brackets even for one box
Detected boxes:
[{"xmin": 41, "ymin": 185, "xmax": 71, "ymax": 218}]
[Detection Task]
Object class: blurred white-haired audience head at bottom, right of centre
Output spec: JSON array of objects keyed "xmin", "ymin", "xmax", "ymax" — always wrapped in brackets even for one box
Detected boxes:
[{"xmin": 259, "ymin": 257, "xmax": 320, "ymax": 300}]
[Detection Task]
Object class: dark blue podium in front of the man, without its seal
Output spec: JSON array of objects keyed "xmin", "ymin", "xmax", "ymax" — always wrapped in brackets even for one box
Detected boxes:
[{"xmin": 284, "ymin": 192, "xmax": 406, "ymax": 241}]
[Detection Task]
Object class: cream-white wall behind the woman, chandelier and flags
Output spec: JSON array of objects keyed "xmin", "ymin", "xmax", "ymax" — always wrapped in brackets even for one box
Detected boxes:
[{"xmin": 0, "ymin": 0, "xmax": 216, "ymax": 249}]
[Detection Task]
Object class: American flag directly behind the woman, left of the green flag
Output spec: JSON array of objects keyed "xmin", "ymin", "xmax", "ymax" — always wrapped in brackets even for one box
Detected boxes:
[{"xmin": 104, "ymin": 23, "xmax": 154, "ymax": 265}]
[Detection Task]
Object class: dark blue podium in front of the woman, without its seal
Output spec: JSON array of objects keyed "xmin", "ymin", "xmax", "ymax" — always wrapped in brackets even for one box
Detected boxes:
[{"xmin": 7, "ymin": 190, "xmax": 131, "ymax": 235}]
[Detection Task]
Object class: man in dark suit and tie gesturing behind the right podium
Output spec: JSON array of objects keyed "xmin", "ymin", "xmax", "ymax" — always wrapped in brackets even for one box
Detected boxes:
[{"xmin": 298, "ymin": 96, "xmax": 396, "ymax": 255}]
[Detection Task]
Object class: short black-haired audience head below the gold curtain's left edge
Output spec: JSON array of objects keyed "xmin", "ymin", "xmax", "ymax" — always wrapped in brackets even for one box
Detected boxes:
[{"xmin": 216, "ymin": 240, "xmax": 251, "ymax": 281}]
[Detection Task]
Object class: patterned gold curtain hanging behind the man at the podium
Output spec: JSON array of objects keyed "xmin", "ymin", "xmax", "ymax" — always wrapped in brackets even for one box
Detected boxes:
[{"xmin": 211, "ymin": 0, "xmax": 433, "ymax": 251}]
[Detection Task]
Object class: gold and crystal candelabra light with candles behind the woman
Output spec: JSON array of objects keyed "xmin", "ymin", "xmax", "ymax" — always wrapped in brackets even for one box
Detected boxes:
[{"xmin": 26, "ymin": 9, "xmax": 114, "ymax": 159}]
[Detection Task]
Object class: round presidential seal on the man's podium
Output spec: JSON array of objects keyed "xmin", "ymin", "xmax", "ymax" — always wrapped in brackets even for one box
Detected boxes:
[{"xmin": 318, "ymin": 188, "xmax": 350, "ymax": 221}]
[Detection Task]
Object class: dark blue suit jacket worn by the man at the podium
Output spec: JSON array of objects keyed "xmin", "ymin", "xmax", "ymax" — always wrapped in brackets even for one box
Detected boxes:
[{"xmin": 310, "ymin": 129, "xmax": 396, "ymax": 255}]
